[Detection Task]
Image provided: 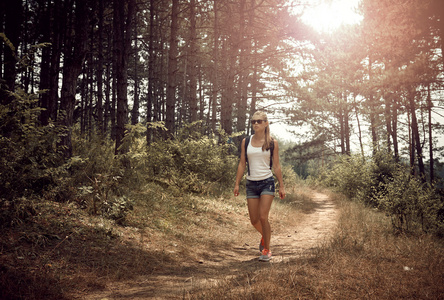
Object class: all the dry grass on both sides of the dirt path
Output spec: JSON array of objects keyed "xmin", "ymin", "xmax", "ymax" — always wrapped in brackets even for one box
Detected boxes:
[{"xmin": 0, "ymin": 185, "xmax": 444, "ymax": 299}]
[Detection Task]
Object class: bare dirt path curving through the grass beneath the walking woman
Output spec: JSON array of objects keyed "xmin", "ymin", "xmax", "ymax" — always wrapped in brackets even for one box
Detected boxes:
[{"xmin": 86, "ymin": 192, "xmax": 337, "ymax": 300}]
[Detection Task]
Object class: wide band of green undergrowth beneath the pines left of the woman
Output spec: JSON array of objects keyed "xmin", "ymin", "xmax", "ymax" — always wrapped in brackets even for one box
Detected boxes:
[{"xmin": 61, "ymin": 123, "xmax": 238, "ymax": 223}]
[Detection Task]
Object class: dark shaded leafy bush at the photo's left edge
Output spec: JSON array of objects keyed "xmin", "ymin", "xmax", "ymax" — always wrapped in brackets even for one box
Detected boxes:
[{"xmin": 0, "ymin": 90, "xmax": 66, "ymax": 200}]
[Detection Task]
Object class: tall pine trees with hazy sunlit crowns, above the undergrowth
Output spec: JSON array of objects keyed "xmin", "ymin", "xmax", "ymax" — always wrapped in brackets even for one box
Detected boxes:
[{"xmin": 1, "ymin": 0, "xmax": 443, "ymax": 164}]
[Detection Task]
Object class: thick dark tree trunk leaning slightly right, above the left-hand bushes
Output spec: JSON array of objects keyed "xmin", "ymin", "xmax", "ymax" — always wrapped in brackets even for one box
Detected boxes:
[{"xmin": 60, "ymin": 0, "xmax": 89, "ymax": 158}]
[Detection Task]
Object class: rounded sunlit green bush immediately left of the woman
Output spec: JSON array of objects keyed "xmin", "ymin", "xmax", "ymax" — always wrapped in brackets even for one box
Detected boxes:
[{"xmin": 139, "ymin": 124, "xmax": 238, "ymax": 193}]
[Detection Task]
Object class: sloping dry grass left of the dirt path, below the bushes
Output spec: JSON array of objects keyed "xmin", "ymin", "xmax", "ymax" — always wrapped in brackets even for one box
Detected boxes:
[{"xmin": 0, "ymin": 184, "xmax": 250, "ymax": 299}]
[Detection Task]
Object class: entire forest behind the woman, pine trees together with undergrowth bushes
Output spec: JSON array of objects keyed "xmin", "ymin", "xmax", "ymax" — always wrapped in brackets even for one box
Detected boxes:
[{"xmin": 0, "ymin": 0, "xmax": 444, "ymax": 297}]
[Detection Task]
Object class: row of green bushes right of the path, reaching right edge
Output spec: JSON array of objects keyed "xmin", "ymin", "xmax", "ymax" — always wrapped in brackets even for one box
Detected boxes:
[{"xmin": 318, "ymin": 152, "xmax": 444, "ymax": 235}]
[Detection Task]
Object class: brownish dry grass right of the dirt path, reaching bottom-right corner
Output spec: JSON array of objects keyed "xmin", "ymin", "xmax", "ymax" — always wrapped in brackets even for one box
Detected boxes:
[{"xmin": 190, "ymin": 193, "xmax": 444, "ymax": 299}]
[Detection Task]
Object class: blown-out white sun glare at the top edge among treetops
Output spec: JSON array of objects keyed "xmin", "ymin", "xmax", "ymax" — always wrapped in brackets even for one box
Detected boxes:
[{"xmin": 302, "ymin": 0, "xmax": 362, "ymax": 32}]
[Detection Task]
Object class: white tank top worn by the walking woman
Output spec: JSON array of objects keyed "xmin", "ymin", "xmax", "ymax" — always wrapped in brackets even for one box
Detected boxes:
[{"xmin": 247, "ymin": 141, "xmax": 273, "ymax": 181}]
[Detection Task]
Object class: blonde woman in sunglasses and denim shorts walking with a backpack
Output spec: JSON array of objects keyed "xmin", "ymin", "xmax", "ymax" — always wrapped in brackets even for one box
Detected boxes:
[{"xmin": 234, "ymin": 111, "xmax": 285, "ymax": 261}]
